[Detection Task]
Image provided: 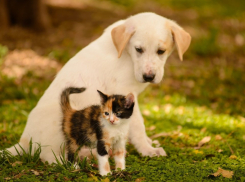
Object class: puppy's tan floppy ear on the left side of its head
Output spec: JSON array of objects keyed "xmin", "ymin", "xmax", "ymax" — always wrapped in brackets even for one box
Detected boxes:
[{"xmin": 111, "ymin": 24, "xmax": 135, "ymax": 58}]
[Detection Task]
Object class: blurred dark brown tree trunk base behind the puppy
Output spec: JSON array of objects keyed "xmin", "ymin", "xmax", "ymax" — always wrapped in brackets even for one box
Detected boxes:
[{"xmin": 0, "ymin": 0, "xmax": 51, "ymax": 31}]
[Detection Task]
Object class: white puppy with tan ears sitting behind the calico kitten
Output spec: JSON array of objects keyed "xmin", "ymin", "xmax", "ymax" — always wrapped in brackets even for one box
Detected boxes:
[{"xmin": 4, "ymin": 13, "xmax": 191, "ymax": 163}]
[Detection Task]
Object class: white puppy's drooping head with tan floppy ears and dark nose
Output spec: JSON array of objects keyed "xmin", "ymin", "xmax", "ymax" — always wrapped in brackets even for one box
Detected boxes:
[{"xmin": 111, "ymin": 13, "xmax": 191, "ymax": 83}]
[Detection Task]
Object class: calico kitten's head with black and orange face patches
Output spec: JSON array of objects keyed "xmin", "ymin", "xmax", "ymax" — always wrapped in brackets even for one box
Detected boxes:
[{"xmin": 98, "ymin": 90, "xmax": 134, "ymax": 125}]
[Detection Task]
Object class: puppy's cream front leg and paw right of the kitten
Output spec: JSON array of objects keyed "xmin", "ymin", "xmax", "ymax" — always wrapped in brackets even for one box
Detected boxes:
[{"xmin": 129, "ymin": 101, "xmax": 167, "ymax": 157}]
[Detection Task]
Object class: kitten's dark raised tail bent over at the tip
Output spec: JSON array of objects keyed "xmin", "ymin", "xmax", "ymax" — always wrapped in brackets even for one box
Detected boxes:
[{"xmin": 60, "ymin": 87, "xmax": 86, "ymax": 115}]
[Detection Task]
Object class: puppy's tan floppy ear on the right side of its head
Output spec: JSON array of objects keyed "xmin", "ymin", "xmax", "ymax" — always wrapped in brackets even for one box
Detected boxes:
[{"xmin": 171, "ymin": 22, "xmax": 191, "ymax": 61}]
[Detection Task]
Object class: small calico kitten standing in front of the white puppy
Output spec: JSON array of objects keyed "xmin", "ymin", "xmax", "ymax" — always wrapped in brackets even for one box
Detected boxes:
[{"xmin": 61, "ymin": 87, "xmax": 134, "ymax": 175}]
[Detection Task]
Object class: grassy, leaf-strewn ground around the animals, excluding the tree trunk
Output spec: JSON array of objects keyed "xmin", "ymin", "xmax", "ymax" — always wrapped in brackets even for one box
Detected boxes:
[{"xmin": 0, "ymin": 0, "xmax": 245, "ymax": 181}]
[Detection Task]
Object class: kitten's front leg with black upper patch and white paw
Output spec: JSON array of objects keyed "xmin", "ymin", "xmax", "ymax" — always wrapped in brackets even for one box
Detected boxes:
[{"xmin": 97, "ymin": 140, "xmax": 111, "ymax": 176}]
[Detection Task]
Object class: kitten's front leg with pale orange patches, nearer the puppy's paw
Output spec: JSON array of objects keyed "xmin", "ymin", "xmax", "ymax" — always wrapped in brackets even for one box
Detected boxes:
[{"xmin": 113, "ymin": 139, "xmax": 126, "ymax": 170}]
